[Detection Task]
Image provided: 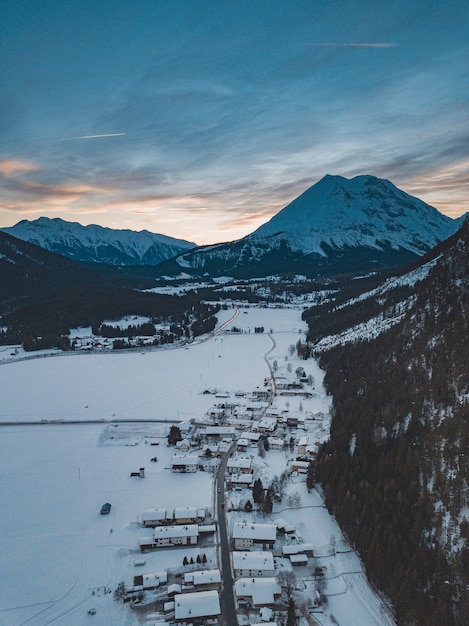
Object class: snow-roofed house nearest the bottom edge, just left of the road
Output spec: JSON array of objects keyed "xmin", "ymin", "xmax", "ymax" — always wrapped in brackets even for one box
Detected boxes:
[{"xmin": 174, "ymin": 590, "xmax": 221, "ymax": 626}]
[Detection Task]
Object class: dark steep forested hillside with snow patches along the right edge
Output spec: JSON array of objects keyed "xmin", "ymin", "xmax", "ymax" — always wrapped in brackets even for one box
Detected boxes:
[{"xmin": 310, "ymin": 221, "xmax": 469, "ymax": 626}]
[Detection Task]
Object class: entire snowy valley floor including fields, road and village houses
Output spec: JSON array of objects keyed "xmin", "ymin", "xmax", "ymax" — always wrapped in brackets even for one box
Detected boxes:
[{"xmin": 0, "ymin": 307, "xmax": 394, "ymax": 626}]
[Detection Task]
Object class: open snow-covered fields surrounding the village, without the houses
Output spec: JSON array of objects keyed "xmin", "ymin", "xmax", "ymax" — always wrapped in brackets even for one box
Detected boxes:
[{"xmin": 0, "ymin": 308, "xmax": 392, "ymax": 626}]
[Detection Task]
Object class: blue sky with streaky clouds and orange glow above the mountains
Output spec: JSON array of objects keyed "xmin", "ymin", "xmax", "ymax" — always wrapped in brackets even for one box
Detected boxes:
[{"xmin": 0, "ymin": 0, "xmax": 469, "ymax": 244}]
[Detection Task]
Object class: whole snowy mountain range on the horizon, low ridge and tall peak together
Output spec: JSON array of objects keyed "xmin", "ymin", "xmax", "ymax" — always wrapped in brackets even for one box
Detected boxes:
[{"xmin": 2, "ymin": 175, "xmax": 462, "ymax": 278}]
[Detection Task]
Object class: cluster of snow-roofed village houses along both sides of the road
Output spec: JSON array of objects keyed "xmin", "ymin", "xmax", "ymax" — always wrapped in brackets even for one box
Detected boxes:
[{"xmin": 101, "ymin": 348, "xmax": 370, "ymax": 626}]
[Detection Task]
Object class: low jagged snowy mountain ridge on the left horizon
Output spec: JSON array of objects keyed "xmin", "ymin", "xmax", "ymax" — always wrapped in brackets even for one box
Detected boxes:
[{"xmin": 1, "ymin": 217, "xmax": 195, "ymax": 266}]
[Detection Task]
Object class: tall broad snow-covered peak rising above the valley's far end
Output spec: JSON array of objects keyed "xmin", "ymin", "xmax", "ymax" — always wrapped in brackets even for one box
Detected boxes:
[{"xmin": 159, "ymin": 175, "xmax": 460, "ymax": 278}]
